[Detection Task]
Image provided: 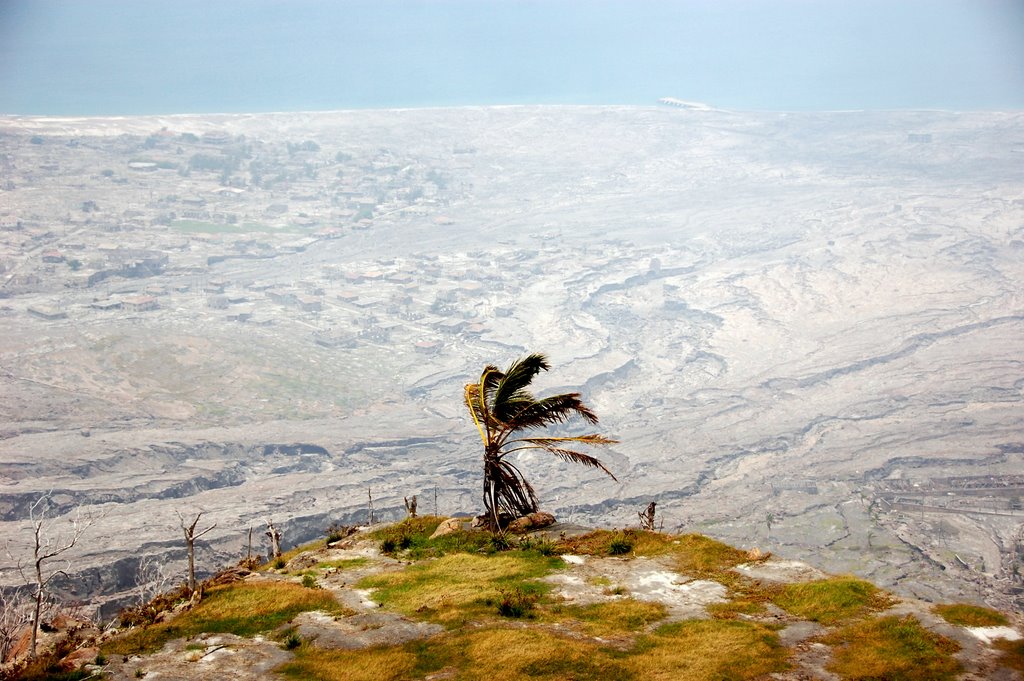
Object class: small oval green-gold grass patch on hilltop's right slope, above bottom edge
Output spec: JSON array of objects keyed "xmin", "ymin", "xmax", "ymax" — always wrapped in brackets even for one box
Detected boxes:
[{"xmin": 772, "ymin": 577, "xmax": 892, "ymax": 625}]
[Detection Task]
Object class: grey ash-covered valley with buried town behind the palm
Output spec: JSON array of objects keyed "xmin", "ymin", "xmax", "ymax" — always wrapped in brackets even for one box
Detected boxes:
[{"xmin": 0, "ymin": 107, "xmax": 1024, "ymax": 608}]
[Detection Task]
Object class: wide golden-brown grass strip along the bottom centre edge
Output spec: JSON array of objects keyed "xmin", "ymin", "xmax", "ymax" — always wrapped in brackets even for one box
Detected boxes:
[{"xmin": 279, "ymin": 610, "xmax": 787, "ymax": 681}]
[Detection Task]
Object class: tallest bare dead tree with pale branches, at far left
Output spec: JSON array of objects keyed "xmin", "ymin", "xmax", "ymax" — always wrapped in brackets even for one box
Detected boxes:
[{"xmin": 7, "ymin": 492, "xmax": 96, "ymax": 659}]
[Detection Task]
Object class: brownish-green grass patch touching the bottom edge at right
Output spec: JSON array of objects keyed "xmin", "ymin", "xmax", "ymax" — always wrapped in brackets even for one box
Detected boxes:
[{"xmin": 822, "ymin": 615, "xmax": 961, "ymax": 681}]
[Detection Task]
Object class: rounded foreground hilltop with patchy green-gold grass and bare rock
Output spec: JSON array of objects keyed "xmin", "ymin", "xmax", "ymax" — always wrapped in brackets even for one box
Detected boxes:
[{"xmin": 9, "ymin": 517, "xmax": 1024, "ymax": 681}]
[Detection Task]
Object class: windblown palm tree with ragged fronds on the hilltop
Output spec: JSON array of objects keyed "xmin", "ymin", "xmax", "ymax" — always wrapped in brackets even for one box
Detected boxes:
[{"xmin": 465, "ymin": 353, "xmax": 617, "ymax": 531}]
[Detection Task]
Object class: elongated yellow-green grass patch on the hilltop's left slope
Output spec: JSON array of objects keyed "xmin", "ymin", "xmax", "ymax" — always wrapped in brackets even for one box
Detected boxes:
[{"xmin": 102, "ymin": 582, "xmax": 351, "ymax": 655}]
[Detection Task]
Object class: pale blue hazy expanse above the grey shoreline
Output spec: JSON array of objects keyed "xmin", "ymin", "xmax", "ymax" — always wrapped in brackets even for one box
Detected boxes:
[{"xmin": 0, "ymin": 0, "xmax": 1024, "ymax": 115}]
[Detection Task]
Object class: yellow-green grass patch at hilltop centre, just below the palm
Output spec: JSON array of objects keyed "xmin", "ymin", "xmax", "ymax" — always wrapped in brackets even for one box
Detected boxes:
[{"xmin": 358, "ymin": 551, "xmax": 563, "ymax": 625}]
